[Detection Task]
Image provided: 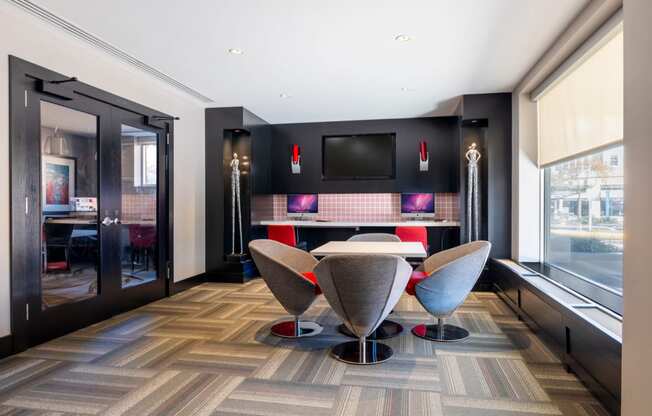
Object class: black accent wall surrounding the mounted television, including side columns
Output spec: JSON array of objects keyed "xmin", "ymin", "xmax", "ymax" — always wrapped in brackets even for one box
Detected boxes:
[{"xmin": 206, "ymin": 93, "xmax": 512, "ymax": 278}]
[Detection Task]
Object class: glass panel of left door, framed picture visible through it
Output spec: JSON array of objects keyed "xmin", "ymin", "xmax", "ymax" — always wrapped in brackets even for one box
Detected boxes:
[{"xmin": 40, "ymin": 101, "xmax": 100, "ymax": 310}]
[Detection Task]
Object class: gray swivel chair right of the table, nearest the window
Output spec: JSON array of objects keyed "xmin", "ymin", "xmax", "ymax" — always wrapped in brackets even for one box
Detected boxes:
[{"xmin": 406, "ymin": 241, "xmax": 491, "ymax": 341}]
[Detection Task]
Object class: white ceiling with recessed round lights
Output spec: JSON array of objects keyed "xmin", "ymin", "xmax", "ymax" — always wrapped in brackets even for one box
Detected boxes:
[{"xmin": 33, "ymin": 0, "xmax": 588, "ymax": 123}]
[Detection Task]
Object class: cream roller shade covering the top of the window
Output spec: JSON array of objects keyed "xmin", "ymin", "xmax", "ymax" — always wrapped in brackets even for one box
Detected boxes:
[{"xmin": 538, "ymin": 26, "xmax": 623, "ymax": 167}]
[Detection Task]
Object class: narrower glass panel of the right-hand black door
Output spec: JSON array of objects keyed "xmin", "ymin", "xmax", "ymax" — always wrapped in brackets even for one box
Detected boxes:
[{"xmin": 120, "ymin": 124, "xmax": 159, "ymax": 289}]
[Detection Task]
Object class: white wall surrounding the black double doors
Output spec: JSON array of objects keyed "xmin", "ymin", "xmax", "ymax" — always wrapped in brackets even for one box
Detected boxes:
[{"xmin": 0, "ymin": 2, "xmax": 205, "ymax": 336}]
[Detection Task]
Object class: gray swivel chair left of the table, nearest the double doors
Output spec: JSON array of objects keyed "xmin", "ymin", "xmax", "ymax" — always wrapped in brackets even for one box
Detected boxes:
[{"xmin": 249, "ymin": 240, "xmax": 323, "ymax": 338}]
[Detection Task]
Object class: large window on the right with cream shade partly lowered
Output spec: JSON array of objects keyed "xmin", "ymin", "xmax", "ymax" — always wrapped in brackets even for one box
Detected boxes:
[{"xmin": 535, "ymin": 19, "xmax": 625, "ymax": 313}]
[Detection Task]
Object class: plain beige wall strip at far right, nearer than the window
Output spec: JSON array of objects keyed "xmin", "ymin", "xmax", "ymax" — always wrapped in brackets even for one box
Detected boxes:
[{"xmin": 622, "ymin": 0, "xmax": 652, "ymax": 416}]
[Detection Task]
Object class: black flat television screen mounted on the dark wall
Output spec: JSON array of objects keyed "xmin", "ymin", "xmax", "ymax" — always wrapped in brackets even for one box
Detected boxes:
[{"xmin": 322, "ymin": 133, "xmax": 396, "ymax": 179}]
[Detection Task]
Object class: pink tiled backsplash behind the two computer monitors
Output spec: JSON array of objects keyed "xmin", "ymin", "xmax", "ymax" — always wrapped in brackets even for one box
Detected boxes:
[{"xmin": 252, "ymin": 193, "xmax": 460, "ymax": 222}]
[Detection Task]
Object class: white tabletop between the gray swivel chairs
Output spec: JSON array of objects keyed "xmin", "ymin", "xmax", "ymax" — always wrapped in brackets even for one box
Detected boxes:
[{"xmin": 310, "ymin": 241, "xmax": 428, "ymax": 258}]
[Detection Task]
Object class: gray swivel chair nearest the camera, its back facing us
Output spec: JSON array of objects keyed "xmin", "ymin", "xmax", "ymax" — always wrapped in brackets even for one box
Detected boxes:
[{"xmin": 315, "ymin": 254, "xmax": 412, "ymax": 364}]
